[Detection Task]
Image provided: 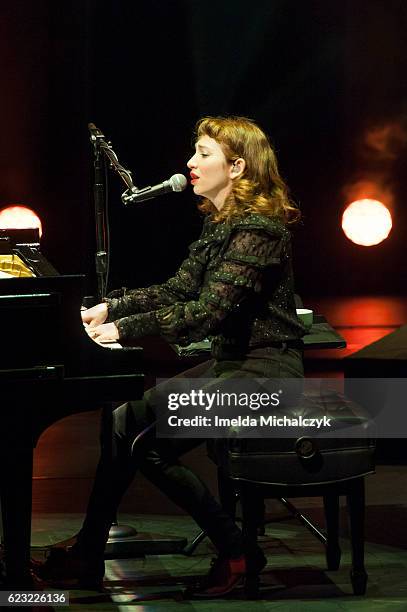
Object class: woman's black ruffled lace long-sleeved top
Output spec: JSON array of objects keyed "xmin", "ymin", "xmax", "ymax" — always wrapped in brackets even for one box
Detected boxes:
[{"xmin": 106, "ymin": 214, "xmax": 305, "ymax": 350}]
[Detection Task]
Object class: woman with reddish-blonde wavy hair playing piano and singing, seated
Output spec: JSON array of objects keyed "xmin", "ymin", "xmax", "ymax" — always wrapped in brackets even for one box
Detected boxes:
[{"xmin": 39, "ymin": 117, "xmax": 304, "ymax": 597}]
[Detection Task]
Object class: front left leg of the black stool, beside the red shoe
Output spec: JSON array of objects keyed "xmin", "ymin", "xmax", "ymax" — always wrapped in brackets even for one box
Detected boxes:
[{"xmin": 240, "ymin": 485, "xmax": 264, "ymax": 599}]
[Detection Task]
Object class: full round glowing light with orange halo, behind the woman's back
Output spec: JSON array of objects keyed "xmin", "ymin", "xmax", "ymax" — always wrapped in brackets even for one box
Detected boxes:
[{"xmin": 342, "ymin": 199, "xmax": 392, "ymax": 246}]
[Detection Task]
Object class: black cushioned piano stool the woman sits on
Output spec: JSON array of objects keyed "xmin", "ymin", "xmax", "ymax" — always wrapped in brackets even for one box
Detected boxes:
[{"xmin": 214, "ymin": 392, "xmax": 375, "ymax": 598}]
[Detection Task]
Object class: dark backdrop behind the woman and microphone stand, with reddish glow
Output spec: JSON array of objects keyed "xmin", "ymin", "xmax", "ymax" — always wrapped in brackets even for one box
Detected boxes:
[{"xmin": 0, "ymin": 0, "xmax": 407, "ymax": 295}]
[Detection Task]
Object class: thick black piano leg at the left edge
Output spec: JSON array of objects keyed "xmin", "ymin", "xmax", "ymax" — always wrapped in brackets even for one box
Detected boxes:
[{"xmin": 0, "ymin": 445, "xmax": 33, "ymax": 588}]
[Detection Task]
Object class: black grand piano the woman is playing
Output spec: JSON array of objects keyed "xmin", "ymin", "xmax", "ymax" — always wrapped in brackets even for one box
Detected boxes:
[{"xmin": 0, "ymin": 230, "xmax": 144, "ymax": 588}]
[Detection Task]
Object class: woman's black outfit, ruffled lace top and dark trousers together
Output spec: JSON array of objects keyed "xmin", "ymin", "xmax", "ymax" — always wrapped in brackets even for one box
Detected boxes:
[{"xmin": 78, "ymin": 214, "xmax": 305, "ymax": 557}]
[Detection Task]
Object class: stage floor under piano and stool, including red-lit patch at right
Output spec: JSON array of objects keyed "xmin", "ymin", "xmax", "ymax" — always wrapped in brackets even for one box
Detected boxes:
[{"xmin": 24, "ymin": 297, "xmax": 407, "ymax": 612}]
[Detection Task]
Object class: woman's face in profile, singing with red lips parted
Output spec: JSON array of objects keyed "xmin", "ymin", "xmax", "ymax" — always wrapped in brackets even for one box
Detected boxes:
[{"xmin": 187, "ymin": 136, "xmax": 233, "ymax": 210}]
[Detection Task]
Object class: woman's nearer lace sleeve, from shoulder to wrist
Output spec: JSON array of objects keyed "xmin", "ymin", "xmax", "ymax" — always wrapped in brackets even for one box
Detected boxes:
[{"xmin": 116, "ymin": 229, "xmax": 281, "ymax": 345}]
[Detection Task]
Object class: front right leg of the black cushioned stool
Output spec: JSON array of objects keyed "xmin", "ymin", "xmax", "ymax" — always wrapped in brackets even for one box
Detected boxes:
[{"xmin": 346, "ymin": 478, "xmax": 367, "ymax": 595}]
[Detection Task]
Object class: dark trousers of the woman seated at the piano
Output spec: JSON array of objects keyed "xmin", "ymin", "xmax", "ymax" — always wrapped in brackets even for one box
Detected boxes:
[{"xmin": 78, "ymin": 348, "xmax": 303, "ymax": 557}]
